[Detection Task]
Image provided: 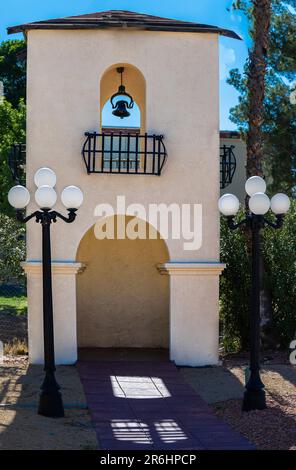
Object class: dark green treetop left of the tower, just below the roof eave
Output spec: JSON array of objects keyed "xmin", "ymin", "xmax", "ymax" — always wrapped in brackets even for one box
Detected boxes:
[{"xmin": 0, "ymin": 40, "xmax": 26, "ymax": 107}]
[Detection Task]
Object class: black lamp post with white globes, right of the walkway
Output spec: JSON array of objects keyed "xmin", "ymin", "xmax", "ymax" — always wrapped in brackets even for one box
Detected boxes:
[{"xmin": 219, "ymin": 176, "xmax": 290, "ymax": 411}]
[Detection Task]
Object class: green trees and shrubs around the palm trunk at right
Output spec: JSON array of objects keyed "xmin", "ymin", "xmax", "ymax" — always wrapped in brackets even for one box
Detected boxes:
[{"xmin": 220, "ymin": 0, "xmax": 296, "ymax": 351}]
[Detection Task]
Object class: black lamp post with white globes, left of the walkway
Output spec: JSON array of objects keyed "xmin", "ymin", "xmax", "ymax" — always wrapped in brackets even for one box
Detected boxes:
[{"xmin": 8, "ymin": 168, "xmax": 83, "ymax": 418}]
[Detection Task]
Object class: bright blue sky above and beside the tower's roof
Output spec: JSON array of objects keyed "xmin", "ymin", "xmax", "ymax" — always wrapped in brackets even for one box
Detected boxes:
[{"xmin": 0, "ymin": 0, "xmax": 249, "ymax": 129}]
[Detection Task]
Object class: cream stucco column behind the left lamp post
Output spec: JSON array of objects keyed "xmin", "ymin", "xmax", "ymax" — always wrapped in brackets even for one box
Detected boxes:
[{"xmin": 22, "ymin": 261, "xmax": 84, "ymax": 364}]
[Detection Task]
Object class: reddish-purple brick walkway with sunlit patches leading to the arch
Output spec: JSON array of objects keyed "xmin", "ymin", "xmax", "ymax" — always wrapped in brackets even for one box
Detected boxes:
[{"xmin": 78, "ymin": 361, "xmax": 253, "ymax": 450}]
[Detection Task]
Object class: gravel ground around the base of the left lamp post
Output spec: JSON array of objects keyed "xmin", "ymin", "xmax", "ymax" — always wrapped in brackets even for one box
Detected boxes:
[{"xmin": 0, "ymin": 358, "xmax": 97, "ymax": 450}]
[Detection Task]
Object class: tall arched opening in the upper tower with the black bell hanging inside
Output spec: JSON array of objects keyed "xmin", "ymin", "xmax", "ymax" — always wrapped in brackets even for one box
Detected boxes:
[{"xmin": 101, "ymin": 64, "xmax": 146, "ymax": 172}]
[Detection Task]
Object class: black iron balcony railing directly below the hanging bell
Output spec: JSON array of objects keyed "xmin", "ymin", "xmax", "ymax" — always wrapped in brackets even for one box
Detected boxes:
[{"xmin": 82, "ymin": 132, "xmax": 167, "ymax": 176}]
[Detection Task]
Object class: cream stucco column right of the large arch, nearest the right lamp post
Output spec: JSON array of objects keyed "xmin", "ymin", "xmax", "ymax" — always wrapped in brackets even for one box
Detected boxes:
[{"xmin": 158, "ymin": 262, "xmax": 225, "ymax": 367}]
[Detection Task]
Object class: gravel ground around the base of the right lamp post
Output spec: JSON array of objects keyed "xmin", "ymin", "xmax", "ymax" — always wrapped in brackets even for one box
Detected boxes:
[{"xmin": 181, "ymin": 356, "xmax": 296, "ymax": 450}]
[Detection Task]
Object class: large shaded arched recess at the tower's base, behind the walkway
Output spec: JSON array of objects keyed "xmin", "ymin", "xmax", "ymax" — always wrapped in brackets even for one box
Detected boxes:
[{"xmin": 77, "ymin": 216, "xmax": 169, "ymax": 348}]
